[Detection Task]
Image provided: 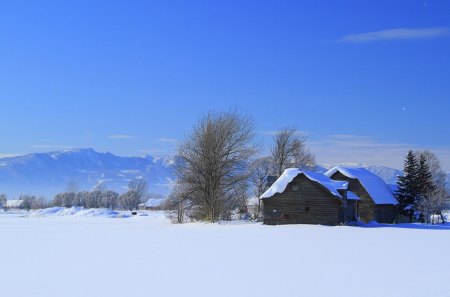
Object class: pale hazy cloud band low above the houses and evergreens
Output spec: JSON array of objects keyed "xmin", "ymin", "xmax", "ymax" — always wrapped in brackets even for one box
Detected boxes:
[{"xmin": 308, "ymin": 135, "xmax": 450, "ymax": 171}]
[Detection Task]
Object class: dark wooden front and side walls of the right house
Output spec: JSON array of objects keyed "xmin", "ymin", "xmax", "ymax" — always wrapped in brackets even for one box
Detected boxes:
[{"xmin": 330, "ymin": 171, "xmax": 397, "ymax": 224}]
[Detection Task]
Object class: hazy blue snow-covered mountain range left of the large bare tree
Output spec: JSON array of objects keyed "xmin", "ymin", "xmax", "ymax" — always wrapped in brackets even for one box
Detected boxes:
[{"xmin": 0, "ymin": 149, "xmax": 174, "ymax": 199}]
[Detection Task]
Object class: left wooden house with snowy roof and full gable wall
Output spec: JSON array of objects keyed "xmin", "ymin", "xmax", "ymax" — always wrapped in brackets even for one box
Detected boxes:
[{"xmin": 260, "ymin": 168, "xmax": 348, "ymax": 225}]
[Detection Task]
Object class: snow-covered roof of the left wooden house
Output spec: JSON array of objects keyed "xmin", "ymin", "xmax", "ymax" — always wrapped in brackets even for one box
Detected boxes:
[{"xmin": 260, "ymin": 168, "xmax": 348, "ymax": 199}]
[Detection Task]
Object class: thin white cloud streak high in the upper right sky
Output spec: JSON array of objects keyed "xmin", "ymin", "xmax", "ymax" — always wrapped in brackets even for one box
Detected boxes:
[{"xmin": 339, "ymin": 27, "xmax": 450, "ymax": 43}]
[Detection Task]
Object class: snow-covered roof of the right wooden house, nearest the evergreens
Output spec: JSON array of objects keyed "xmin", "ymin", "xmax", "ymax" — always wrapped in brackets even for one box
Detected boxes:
[{"xmin": 325, "ymin": 166, "xmax": 398, "ymax": 205}]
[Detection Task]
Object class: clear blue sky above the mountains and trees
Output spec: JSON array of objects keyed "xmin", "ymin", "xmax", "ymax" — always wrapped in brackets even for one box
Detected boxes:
[{"xmin": 0, "ymin": 0, "xmax": 450, "ymax": 170}]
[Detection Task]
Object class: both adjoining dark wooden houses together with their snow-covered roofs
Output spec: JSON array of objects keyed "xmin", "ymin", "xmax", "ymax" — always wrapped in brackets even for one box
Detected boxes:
[{"xmin": 260, "ymin": 167, "xmax": 398, "ymax": 225}]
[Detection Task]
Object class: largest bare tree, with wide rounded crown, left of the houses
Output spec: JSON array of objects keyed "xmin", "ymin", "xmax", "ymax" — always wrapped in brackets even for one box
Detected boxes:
[{"xmin": 175, "ymin": 111, "xmax": 256, "ymax": 222}]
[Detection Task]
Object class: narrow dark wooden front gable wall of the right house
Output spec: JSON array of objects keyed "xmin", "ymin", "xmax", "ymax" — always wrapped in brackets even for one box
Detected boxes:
[{"xmin": 331, "ymin": 171, "xmax": 376, "ymax": 223}]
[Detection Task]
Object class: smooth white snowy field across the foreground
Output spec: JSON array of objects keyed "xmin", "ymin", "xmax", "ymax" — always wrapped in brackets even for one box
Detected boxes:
[{"xmin": 0, "ymin": 209, "xmax": 450, "ymax": 297}]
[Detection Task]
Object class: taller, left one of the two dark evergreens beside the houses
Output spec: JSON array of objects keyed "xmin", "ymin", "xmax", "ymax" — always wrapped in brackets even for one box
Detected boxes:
[{"xmin": 396, "ymin": 151, "xmax": 419, "ymax": 221}]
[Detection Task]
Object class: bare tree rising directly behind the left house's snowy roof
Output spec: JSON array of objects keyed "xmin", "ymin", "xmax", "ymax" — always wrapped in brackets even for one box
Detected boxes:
[{"xmin": 272, "ymin": 128, "xmax": 315, "ymax": 176}]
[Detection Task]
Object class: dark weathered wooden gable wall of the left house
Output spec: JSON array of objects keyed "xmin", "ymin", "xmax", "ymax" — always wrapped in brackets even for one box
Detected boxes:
[{"xmin": 262, "ymin": 174, "xmax": 344, "ymax": 225}]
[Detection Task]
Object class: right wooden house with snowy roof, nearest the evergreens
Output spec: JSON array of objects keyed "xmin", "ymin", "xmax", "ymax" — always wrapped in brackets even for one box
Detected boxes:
[{"xmin": 325, "ymin": 166, "xmax": 398, "ymax": 223}]
